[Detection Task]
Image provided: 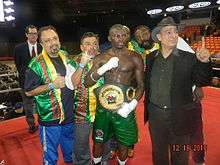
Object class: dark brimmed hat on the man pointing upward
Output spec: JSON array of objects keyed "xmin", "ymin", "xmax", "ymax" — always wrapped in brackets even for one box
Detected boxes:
[{"xmin": 151, "ymin": 17, "xmax": 178, "ymax": 42}]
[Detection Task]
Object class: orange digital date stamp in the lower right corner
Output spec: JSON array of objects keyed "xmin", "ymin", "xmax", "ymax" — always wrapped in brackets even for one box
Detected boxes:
[{"xmin": 170, "ymin": 144, "xmax": 207, "ymax": 152}]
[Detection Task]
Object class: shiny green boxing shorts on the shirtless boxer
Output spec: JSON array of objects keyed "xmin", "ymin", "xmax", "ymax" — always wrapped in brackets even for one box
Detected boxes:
[{"xmin": 93, "ymin": 103, "xmax": 138, "ymax": 147}]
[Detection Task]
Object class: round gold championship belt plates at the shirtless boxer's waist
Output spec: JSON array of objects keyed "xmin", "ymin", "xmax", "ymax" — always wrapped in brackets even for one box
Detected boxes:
[{"xmin": 98, "ymin": 85, "xmax": 135, "ymax": 112}]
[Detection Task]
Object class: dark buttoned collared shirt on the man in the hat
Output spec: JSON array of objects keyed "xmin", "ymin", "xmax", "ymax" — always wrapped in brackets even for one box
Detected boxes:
[{"xmin": 149, "ymin": 49, "xmax": 177, "ymax": 108}]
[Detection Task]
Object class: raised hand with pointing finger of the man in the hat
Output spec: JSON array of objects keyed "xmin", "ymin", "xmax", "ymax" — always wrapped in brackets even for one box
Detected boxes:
[{"xmin": 196, "ymin": 37, "xmax": 210, "ymax": 63}]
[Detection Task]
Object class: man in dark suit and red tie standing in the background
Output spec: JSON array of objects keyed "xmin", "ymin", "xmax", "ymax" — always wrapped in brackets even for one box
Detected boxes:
[{"xmin": 14, "ymin": 25, "xmax": 42, "ymax": 133}]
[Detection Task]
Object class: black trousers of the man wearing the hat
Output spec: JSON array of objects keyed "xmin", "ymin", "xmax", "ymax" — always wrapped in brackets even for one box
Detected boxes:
[{"xmin": 148, "ymin": 103, "xmax": 190, "ymax": 165}]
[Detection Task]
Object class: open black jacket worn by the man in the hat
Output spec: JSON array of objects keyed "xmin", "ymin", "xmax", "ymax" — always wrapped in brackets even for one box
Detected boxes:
[{"xmin": 144, "ymin": 49, "xmax": 212, "ymax": 134}]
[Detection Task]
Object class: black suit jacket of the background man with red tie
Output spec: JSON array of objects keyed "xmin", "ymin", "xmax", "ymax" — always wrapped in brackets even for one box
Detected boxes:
[{"xmin": 14, "ymin": 42, "xmax": 42, "ymax": 89}]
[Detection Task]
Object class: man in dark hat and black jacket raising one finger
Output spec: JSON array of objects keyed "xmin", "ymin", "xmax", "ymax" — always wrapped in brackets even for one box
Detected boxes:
[{"xmin": 144, "ymin": 17, "xmax": 211, "ymax": 165}]
